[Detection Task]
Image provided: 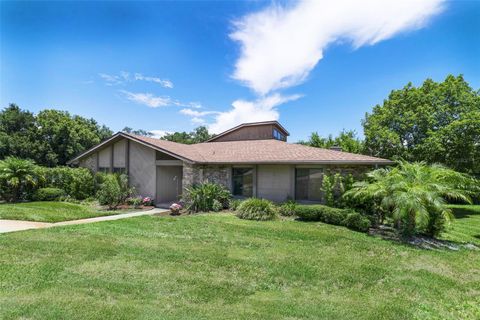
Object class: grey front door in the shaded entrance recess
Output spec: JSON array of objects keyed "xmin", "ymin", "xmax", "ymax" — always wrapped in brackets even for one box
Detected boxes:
[{"xmin": 156, "ymin": 166, "xmax": 183, "ymax": 205}]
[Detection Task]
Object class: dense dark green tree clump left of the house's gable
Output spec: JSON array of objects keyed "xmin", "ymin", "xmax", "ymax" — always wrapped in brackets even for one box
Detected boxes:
[{"xmin": 0, "ymin": 104, "xmax": 112, "ymax": 166}]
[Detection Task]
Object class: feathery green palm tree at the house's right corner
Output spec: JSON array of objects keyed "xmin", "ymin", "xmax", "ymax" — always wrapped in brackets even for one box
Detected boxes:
[{"xmin": 345, "ymin": 161, "xmax": 472, "ymax": 236}]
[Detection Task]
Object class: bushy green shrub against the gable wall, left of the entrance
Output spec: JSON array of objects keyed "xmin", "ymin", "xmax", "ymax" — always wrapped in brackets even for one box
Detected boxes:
[{"xmin": 97, "ymin": 174, "xmax": 134, "ymax": 209}]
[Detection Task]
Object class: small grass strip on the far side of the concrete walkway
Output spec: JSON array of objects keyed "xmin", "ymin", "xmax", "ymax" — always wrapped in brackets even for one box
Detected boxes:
[{"xmin": 0, "ymin": 201, "xmax": 125, "ymax": 222}]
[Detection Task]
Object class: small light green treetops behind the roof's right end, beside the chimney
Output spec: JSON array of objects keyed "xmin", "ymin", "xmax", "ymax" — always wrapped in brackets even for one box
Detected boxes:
[{"xmin": 298, "ymin": 130, "xmax": 363, "ymax": 153}]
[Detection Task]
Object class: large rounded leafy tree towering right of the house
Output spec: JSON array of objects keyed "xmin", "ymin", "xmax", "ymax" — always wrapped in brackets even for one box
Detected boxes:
[{"xmin": 363, "ymin": 75, "xmax": 480, "ymax": 175}]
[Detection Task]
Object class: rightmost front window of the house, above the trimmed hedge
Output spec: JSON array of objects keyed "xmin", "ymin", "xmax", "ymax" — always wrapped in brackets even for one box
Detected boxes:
[{"xmin": 295, "ymin": 168, "xmax": 323, "ymax": 201}]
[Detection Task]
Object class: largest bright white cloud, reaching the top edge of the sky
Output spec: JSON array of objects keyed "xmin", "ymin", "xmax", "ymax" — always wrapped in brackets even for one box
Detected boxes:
[{"xmin": 230, "ymin": 0, "xmax": 444, "ymax": 95}]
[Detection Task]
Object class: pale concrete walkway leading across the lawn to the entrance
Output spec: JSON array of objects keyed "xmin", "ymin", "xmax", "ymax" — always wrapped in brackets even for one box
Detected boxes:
[{"xmin": 0, "ymin": 208, "xmax": 170, "ymax": 233}]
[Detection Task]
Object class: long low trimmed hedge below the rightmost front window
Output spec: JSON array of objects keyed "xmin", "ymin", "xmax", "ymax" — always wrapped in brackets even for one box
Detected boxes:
[{"xmin": 295, "ymin": 204, "xmax": 371, "ymax": 232}]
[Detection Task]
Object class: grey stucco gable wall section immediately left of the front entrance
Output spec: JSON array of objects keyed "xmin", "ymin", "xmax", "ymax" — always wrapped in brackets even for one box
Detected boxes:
[{"xmin": 129, "ymin": 141, "xmax": 156, "ymax": 198}]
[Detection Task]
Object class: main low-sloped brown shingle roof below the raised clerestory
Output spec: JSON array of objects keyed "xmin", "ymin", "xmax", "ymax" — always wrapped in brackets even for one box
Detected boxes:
[{"xmin": 127, "ymin": 135, "xmax": 391, "ymax": 164}]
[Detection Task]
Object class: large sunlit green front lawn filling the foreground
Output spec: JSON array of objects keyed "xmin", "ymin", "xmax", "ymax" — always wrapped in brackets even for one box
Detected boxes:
[{"xmin": 0, "ymin": 209, "xmax": 480, "ymax": 320}]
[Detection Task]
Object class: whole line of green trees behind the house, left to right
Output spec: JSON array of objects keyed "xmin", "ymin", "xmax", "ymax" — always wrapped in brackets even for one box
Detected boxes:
[{"xmin": 0, "ymin": 75, "xmax": 480, "ymax": 175}]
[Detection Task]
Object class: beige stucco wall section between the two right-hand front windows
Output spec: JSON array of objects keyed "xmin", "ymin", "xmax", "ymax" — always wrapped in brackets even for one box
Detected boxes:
[{"xmin": 257, "ymin": 165, "xmax": 295, "ymax": 202}]
